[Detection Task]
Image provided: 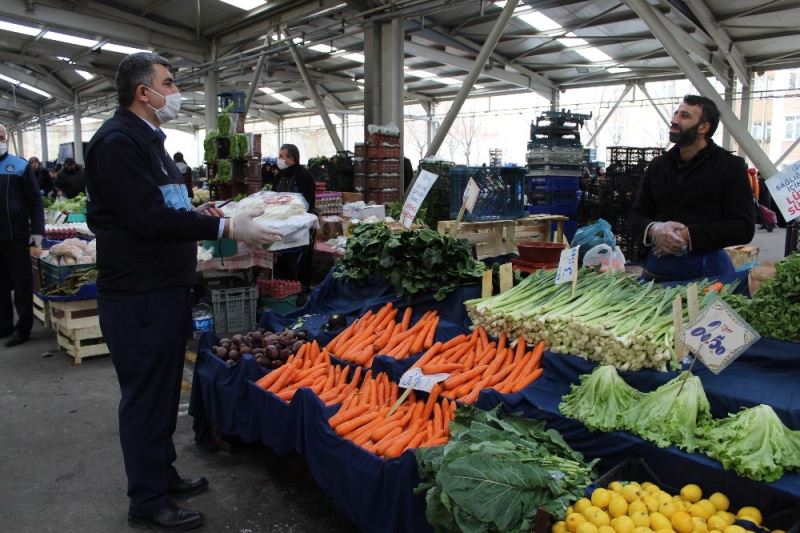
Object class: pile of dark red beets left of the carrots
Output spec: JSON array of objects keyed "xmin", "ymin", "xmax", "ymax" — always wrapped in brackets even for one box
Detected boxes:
[{"xmin": 212, "ymin": 328, "xmax": 308, "ymax": 368}]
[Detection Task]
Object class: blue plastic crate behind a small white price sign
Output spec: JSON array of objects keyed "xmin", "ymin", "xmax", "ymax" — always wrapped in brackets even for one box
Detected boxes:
[{"xmin": 450, "ymin": 166, "xmax": 527, "ymax": 221}]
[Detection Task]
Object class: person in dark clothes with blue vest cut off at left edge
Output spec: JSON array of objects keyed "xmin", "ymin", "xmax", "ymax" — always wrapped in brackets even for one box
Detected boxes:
[{"xmin": 0, "ymin": 124, "xmax": 44, "ymax": 348}]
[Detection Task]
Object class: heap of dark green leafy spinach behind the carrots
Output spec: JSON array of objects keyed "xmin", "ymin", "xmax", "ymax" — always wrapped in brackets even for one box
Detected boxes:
[{"xmin": 333, "ymin": 223, "xmax": 485, "ymax": 300}]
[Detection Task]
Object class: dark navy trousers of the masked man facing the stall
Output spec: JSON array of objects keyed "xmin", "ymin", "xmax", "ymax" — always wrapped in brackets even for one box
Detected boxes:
[{"xmin": 97, "ymin": 287, "xmax": 191, "ymax": 515}]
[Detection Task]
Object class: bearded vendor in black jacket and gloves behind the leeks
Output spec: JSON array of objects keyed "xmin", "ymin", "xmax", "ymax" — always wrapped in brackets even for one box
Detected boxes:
[{"xmin": 628, "ymin": 95, "xmax": 755, "ymax": 280}]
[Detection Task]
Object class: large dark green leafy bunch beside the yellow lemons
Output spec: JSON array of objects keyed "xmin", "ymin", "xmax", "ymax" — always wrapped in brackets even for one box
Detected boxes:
[{"xmin": 415, "ymin": 406, "xmax": 594, "ymax": 533}]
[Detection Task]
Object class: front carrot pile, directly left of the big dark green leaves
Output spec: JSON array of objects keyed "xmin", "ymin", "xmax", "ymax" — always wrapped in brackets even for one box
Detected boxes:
[{"xmin": 328, "ymin": 372, "xmax": 456, "ymax": 459}]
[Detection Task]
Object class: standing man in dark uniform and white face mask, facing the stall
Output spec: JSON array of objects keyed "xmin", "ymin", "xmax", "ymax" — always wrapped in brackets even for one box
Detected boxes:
[{"xmin": 86, "ymin": 52, "xmax": 279, "ymax": 531}]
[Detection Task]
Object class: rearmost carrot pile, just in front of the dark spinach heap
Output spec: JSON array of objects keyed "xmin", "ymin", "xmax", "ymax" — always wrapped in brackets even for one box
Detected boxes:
[{"xmin": 325, "ymin": 303, "xmax": 439, "ymax": 367}]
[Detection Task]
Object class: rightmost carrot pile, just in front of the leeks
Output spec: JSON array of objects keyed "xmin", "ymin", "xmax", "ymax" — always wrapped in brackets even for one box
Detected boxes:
[{"xmin": 414, "ymin": 326, "xmax": 544, "ymax": 403}]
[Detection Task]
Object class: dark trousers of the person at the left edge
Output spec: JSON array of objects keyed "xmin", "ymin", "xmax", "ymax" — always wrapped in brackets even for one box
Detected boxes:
[{"xmin": 0, "ymin": 239, "xmax": 33, "ymax": 335}]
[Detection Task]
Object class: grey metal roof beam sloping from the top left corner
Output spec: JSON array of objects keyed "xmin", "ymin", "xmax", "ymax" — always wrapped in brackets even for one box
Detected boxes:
[{"xmin": 3, "ymin": 2, "xmax": 205, "ymax": 62}]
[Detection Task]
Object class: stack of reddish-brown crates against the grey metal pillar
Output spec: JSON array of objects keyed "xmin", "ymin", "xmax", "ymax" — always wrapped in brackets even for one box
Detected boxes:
[{"xmin": 353, "ymin": 132, "xmax": 403, "ymax": 204}]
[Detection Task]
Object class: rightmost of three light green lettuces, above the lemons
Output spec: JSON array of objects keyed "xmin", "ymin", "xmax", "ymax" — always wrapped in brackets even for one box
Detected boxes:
[{"xmin": 698, "ymin": 405, "xmax": 800, "ymax": 481}]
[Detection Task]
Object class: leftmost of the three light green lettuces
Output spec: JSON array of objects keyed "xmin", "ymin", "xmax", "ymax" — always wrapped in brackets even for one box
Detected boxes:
[{"xmin": 558, "ymin": 365, "xmax": 644, "ymax": 431}]
